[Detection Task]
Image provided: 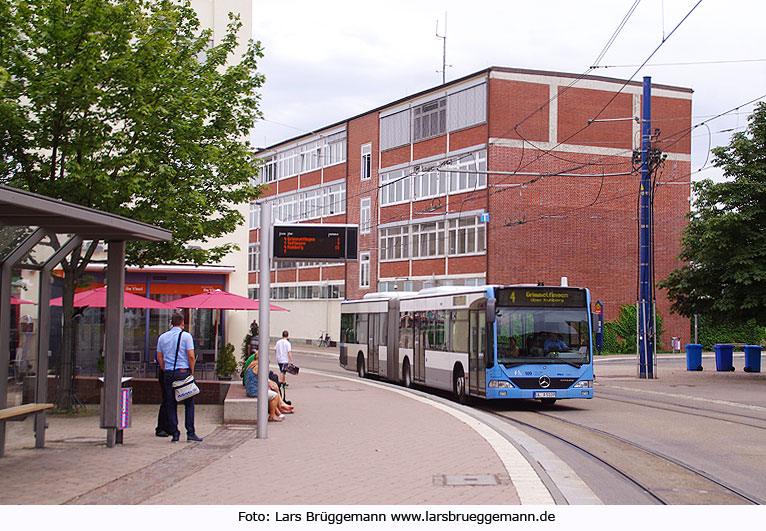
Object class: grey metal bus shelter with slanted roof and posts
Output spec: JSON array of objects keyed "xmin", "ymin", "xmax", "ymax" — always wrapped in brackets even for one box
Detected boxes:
[{"xmin": 0, "ymin": 185, "xmax": 172, "ymax": 457}]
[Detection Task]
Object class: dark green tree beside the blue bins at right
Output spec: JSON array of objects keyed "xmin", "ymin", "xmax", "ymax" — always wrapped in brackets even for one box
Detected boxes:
[{"xmin": 660, "ymin": 102, "xmax": 766, "ymax": 323}]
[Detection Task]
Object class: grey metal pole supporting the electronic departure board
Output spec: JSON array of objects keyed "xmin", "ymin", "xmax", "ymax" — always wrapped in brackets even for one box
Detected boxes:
[{"xmin": 257, "ymin": 200, "xmax": 271, "ymax": 439}]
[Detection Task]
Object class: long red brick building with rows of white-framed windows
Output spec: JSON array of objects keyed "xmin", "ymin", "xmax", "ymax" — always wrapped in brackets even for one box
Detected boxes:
[{"xmin": 250, "ymin": 67, "xmax": 692, "ymax": 345}]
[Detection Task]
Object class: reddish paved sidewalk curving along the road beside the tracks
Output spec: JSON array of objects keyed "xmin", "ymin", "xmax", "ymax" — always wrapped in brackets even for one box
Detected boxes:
[{"xmin": 0, "ymin": 371, "xmax": 564, "ymax": 505}]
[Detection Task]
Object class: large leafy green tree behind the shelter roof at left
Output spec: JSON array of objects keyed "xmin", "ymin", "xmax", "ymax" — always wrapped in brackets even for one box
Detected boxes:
[{"xmin": 0, "ymin": 0, "xmax": 263, "ymax": 412}]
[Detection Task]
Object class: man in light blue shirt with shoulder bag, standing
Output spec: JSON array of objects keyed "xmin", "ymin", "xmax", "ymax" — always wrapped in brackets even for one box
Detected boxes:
[{"xmin": 157, "ymin": 312, "xmax": 202, "ymax": 442}]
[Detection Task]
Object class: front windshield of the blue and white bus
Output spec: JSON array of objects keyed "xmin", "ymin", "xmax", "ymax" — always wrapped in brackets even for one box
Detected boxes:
[{"xmin": 495, "ymin": 308, "xmax": 590, "ymax": 367}]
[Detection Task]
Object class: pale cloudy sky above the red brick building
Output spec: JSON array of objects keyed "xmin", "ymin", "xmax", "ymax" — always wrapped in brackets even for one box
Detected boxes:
[{"xmin": 252, "ymin": 0, "xmax": 766, "ymax": 180}]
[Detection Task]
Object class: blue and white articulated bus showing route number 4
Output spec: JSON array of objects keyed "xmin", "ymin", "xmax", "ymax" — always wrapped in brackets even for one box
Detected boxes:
[{"xmin": 340, "ymin": 285, "xmax": 593, "ymax": 404}]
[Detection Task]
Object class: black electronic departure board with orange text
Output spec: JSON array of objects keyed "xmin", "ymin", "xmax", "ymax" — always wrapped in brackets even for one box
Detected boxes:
[{"xmin": 272, "ymin": 223, "xmax": 359, "ymax": 260}]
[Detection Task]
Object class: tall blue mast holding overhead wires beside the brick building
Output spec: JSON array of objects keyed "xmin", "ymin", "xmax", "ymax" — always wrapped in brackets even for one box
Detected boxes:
[{"xmin": 638, "ymin": 76, "xmax": 654, "ymax": 378}]
